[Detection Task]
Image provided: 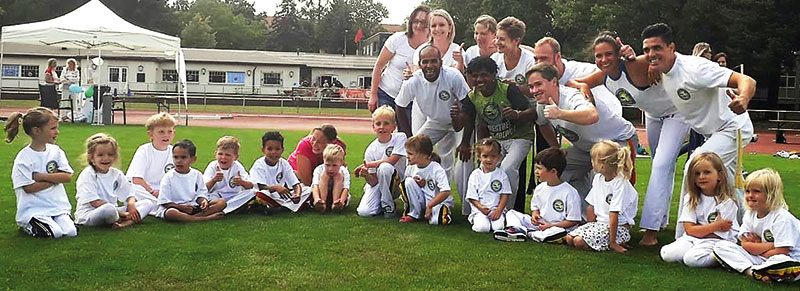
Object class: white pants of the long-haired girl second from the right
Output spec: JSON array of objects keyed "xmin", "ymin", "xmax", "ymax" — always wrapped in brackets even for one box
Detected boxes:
[{"xmin": 661, "ymin": 235, "xmax": 723, "ymax": 268}]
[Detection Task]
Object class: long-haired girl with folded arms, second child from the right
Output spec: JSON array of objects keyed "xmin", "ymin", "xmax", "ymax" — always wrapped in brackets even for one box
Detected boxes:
[{"xmin": 661, "ymin": 153, "xmax": 739, "ymax": 267}]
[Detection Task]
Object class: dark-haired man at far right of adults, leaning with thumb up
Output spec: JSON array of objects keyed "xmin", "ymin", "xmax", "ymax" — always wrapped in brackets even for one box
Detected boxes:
[{"xmin": 642, "ymin": 23, "xmax": 756, "ymax": 237}]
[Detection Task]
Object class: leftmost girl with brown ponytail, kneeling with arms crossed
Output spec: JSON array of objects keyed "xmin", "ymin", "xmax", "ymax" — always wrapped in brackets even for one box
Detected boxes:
[{"xmin": 4, "ymin": 107, "xmax": 78, "ymax": 238}]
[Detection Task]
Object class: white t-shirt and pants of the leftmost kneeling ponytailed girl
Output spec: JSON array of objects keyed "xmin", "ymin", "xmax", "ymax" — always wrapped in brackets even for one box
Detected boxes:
[{"xmin": 11, "ymin": 144, "xmax": 78, "ymax": 238}]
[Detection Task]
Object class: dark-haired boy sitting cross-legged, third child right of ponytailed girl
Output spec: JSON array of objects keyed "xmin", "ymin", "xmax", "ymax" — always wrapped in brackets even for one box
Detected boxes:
[{"xmin": 156, "ymin": 139, "xmax": 227, "ymax": 222}]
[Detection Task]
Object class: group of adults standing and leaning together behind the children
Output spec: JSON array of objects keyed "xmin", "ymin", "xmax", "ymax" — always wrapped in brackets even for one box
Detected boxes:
[{"xmin": 369, "ymin": 6, "xmax": 755, "ymax": 245}]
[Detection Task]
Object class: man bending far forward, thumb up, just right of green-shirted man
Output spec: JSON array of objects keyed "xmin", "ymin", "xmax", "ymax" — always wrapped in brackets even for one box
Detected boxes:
[{"xmin": 527, "ymin": 64, "xmax": 636, "ymax": 213}]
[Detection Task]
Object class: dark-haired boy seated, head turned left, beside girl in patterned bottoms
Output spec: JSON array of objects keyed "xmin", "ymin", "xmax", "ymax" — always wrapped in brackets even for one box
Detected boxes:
[{"xmin": 494, "ymin": 148, "xmax": 581, "ymax": 243}]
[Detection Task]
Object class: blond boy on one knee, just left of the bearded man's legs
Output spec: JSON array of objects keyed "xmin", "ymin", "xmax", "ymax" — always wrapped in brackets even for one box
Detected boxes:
[{"xmin": 353, "ymin": 105, "xmax": 407, "ymax": 217}]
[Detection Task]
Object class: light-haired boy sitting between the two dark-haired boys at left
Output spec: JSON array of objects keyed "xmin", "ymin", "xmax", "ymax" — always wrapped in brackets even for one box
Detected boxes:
[{"xmin": 203, "ymin": 136, "xmax": 255, "ymax": 214}]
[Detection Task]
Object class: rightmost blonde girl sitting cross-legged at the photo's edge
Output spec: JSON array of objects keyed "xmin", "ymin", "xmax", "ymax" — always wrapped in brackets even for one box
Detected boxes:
[{"xmin": 714, "ymin": 168, "xmax": 800, "ymax": 282}]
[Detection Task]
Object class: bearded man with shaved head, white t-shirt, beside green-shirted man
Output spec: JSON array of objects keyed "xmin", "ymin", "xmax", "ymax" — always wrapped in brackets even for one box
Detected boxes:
[{"xmin": 395, "ymin": 46, "xmax": 470, "ymax": 177}]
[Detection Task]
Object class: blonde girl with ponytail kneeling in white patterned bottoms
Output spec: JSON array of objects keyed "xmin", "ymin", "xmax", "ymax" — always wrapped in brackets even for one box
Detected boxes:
[{"xmin": 566, "ymin": 140, "xmax": 639, "ymax": 253}]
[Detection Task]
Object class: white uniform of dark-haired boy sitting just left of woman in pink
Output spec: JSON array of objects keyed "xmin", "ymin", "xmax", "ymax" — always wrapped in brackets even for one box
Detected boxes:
[{"xmin": 250, "ymin": 157, "xmax": 311, "ymax": 212}]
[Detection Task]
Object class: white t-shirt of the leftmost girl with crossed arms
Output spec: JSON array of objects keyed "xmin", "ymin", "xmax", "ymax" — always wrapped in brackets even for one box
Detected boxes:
[{"xmin": 11, "ymin": 144, "xmax": 74, "ymax": 227}]
